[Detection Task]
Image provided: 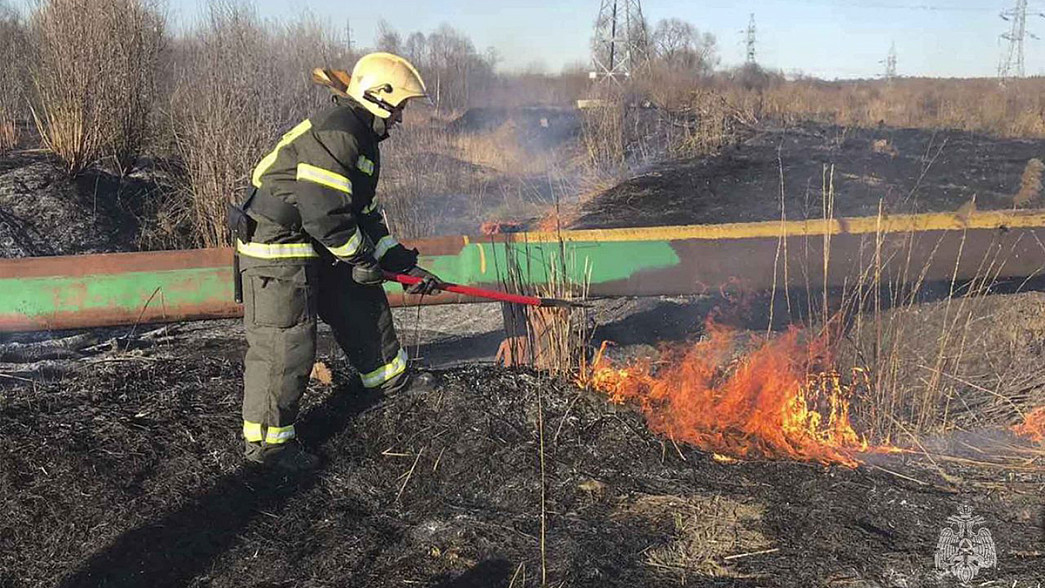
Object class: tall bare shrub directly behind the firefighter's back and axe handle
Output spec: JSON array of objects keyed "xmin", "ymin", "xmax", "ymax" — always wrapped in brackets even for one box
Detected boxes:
[{"xmin": 171, "ymin": 0, "xmax": 351, "ymax": 246}]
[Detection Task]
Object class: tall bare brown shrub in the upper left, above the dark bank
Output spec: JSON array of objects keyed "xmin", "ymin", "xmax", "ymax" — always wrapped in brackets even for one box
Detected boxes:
[{"xmin": 31, "ymin": 0, "xmax": 164, "ymax": 174}]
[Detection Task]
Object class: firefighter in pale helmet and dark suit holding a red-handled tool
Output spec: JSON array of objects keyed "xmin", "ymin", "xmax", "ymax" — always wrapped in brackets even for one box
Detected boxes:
[{"xmin": 230, "ymin": 53, "xmax": 441, "ymax": 471}]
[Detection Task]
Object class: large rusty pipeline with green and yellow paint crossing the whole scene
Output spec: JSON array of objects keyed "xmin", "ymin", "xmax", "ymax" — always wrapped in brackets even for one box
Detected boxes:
[{"xmin": 0, "ymin": 211, "xmax": 1045, "ymax": 332}]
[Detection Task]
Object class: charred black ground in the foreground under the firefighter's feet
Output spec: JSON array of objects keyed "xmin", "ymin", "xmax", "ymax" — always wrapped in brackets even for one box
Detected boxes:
[{"xmin": 0, "ymin": 335, "xmax": 1045, "ymax": 588}]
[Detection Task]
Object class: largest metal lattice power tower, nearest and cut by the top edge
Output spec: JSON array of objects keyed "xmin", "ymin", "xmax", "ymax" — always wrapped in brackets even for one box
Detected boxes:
[{"xmin": 589, "ymin": 0, "xmax": 649, "ymax": 81}]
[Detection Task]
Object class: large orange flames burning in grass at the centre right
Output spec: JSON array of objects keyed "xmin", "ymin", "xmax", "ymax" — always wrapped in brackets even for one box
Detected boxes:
[{"xmin": 582, "ymin": 323, "xmax": 891, "ymax": 467}]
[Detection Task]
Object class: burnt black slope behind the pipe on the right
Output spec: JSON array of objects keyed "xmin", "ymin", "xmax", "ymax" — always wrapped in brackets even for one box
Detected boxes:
[{"xmin": 572, "ymin": 124, "xmax": 1045, "ymax": 229}]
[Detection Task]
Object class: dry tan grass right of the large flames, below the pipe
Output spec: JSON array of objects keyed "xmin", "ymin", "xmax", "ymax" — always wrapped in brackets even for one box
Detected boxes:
[{"xmin": 784, "ymin": 171, "xmax": 1045, "ymax": 444}]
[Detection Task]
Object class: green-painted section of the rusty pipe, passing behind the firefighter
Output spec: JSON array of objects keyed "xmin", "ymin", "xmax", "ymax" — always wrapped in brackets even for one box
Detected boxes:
[{"xmin": 0, "ymin": 241, "xmax": 679, "ymax": 331}]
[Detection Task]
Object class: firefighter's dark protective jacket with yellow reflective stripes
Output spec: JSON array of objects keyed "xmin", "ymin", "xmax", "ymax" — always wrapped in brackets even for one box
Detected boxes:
[{"xmin": 236, "ymin": 98, "xmax": 407, "ymax": 271}]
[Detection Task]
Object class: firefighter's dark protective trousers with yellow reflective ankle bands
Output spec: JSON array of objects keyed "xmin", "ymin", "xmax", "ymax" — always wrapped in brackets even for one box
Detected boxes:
[{"xmin": 241, "ymin": 260, "xmax": 407, "ymax": 445}]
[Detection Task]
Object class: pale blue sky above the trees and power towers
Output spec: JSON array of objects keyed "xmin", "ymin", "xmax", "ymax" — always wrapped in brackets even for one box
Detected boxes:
[{"xmin": 169, "ymin": 0, "xmax": 1045, "ymax": 78}]
